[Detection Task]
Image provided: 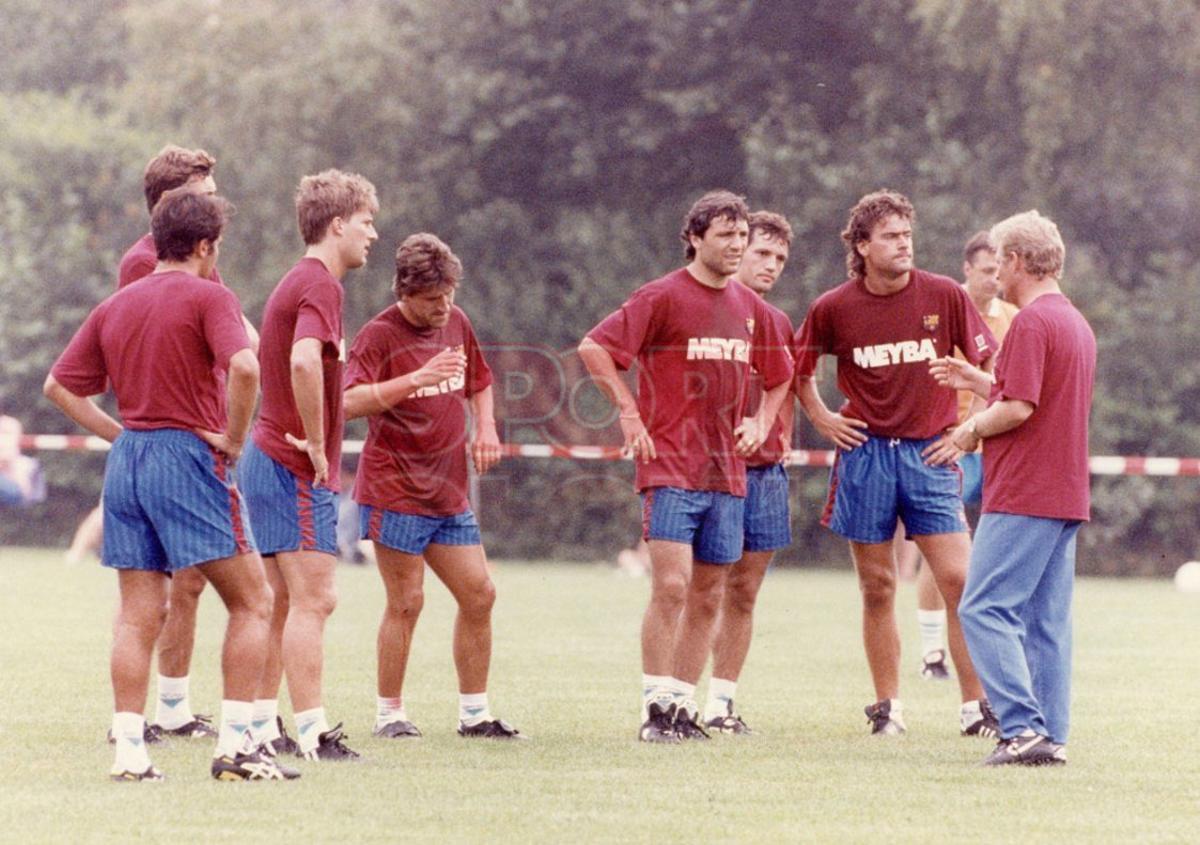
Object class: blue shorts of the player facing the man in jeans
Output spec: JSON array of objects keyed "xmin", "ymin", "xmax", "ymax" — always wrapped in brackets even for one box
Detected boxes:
[{"xmin": 821, "ymin": 436, "xmax": 967, "ymax": 543}]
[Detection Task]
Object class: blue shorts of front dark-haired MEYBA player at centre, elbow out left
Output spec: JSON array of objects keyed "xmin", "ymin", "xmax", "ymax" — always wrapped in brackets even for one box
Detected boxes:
[{"xmin": 642, "ymin": 487, "xmax": 746, "ymax": 563}]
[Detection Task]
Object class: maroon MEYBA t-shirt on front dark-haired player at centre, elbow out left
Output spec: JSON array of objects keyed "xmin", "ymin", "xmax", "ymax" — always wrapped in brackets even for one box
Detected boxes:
[{"xmin": 588, "ymin": 269, "xmax": 792, "ymax": 496}]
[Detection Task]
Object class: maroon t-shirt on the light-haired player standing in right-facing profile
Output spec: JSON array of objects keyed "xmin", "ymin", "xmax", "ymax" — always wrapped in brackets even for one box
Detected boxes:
[{"xmin": 253, "ymin": 258, "xmax": 346, "ymax": 492}]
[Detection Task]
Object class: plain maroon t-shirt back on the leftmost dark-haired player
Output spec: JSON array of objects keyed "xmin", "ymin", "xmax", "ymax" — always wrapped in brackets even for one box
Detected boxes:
[{"xmin": 50, "ymin": 270, "xmax": 250, "ymax": 432}]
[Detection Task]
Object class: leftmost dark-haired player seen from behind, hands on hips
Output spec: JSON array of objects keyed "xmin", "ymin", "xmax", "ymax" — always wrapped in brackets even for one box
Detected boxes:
[{"xmin": 46, "ymin": 188, "xmax": 299, "ymax": 781}]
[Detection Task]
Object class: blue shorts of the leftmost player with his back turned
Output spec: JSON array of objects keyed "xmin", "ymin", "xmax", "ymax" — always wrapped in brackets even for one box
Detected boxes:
[{"xmin": 101, "ymin": 429, "xmax": 254, "ymax": 573}]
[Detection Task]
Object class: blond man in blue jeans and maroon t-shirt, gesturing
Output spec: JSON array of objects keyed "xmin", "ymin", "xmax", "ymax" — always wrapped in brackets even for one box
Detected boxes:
[{"xmin": 932, "ymin": 211, "xmax": 1096, "ymax": 766}]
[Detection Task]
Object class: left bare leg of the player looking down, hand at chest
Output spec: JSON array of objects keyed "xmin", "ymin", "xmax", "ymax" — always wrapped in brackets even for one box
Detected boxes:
[{"xmin": 374, "ymin": 543, "xmax": 425, "ymax": 715}]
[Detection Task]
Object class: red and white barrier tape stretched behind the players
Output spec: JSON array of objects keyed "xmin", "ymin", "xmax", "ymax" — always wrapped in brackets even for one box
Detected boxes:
[{"xmin": 20, "ymin": 435, "xmax": 1200, "ymax": 475}]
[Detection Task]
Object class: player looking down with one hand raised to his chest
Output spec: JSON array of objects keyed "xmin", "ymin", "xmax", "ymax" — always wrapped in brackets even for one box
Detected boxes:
[{"xmin": 346, "ymin": 233, "xmax": 523, "ymax": 739}]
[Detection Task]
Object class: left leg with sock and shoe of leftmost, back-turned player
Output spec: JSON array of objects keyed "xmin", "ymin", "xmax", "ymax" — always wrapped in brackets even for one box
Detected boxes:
[{"xmin": 109, "ymin": 569, "xmax": 167, "ymax": 780}]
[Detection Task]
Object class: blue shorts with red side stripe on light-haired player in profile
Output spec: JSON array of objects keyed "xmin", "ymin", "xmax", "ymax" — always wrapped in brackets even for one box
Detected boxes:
[{"xmin": 238, "ymin": 441, "xmax": 337, "ymax": 556}]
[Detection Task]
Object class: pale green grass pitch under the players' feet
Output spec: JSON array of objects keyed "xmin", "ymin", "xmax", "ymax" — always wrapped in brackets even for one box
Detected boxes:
[{"xmin": 0, "ymin": 549, "xmax": 1200, "ymax": 843}]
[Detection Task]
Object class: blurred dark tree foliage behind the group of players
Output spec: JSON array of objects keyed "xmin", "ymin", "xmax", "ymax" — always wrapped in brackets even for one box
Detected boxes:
[{"xmin": 0, "ymin": 0, "xmax": 1200, "ymax": 570}]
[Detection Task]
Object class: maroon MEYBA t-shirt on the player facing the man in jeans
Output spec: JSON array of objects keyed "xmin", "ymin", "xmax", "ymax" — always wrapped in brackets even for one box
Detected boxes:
[{"xmin": 796, "ymin": 270, "xmax": 998, "ymax": 439}]
